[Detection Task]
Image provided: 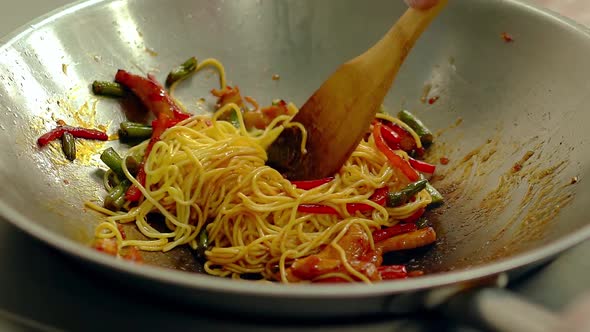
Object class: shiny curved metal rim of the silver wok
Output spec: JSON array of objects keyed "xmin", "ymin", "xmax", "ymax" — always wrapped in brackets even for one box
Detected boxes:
[{"xmin": 0, "ymin": 0, "xmax": 590, "ymax": 299}]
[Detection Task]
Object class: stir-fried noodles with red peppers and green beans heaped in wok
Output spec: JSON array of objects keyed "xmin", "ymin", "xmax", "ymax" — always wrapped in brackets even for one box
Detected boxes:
[{"xmin": 38, "ymin": 58, "xmax": 443, "ymax": 283}]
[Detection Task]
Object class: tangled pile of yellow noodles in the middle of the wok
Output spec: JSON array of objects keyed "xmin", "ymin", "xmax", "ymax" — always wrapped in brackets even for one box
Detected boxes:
[{"xmin": 90, "ymin": 60, "xmax": 431, "ymax": 282}]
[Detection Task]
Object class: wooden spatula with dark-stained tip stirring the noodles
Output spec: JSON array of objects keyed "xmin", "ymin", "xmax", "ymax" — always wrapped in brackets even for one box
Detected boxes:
[{"xmin": 267, "ymin": 0, "xmax": 448, "ymax": 180}]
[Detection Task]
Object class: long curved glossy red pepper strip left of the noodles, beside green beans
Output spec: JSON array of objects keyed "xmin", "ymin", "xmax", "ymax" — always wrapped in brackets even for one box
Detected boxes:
[{"xmin": 115, "ymin": 70, "xmax": 190, "ymax": 202}]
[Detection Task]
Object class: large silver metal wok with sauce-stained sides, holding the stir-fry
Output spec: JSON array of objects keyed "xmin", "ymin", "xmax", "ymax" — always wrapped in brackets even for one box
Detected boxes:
[{"xmin": 0, "ymin": 0, "xmax": 590, "ymax": 326}]
